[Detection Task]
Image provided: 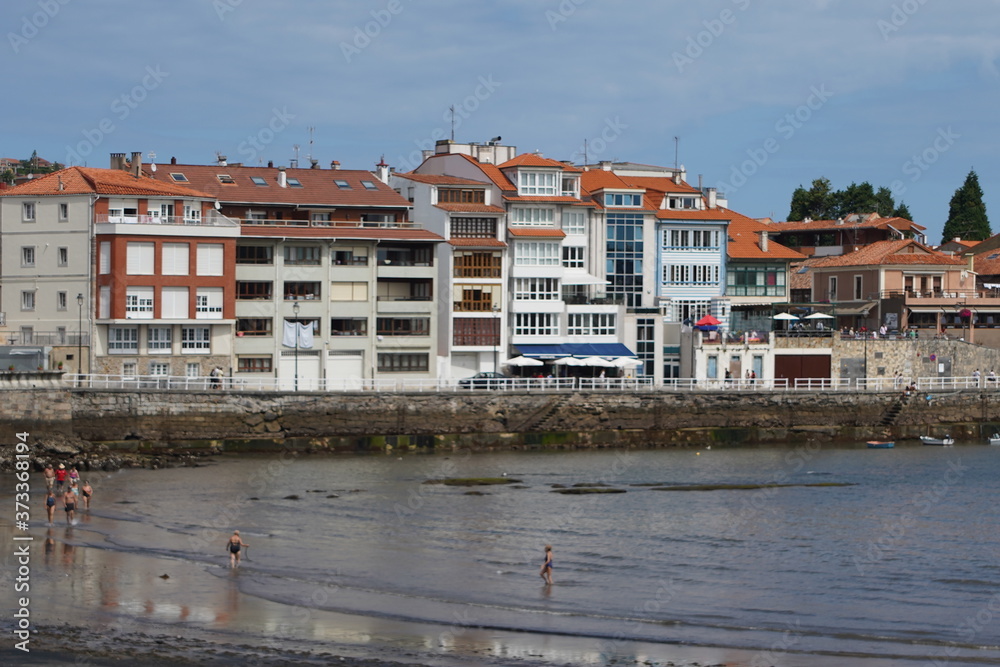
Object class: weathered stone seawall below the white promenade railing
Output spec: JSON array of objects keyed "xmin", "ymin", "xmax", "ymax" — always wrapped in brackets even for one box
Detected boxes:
[{"xmin": 0, "ymin": 388, "xmax": 1000, "ymax": 448}]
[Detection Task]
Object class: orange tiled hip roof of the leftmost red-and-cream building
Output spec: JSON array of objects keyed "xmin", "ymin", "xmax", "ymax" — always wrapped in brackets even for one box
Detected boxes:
[{"xmin": 0, "ymin": 167, "xmax": 215, "ymax": 199}]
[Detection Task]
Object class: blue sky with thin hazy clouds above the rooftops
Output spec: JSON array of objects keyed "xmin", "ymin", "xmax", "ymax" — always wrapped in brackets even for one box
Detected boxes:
[{"xmin": 0, "ymin": 0, "xmax": 1000, "ymax": 244}]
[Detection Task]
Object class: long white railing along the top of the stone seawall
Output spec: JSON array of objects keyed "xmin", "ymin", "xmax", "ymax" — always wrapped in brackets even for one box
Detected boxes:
[{"xmin": 63, "ymin": 373, "xmax": 1000, "ymax": 393}]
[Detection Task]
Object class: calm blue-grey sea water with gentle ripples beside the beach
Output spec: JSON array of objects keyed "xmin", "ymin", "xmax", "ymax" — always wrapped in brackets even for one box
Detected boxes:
[{"xmin": 17, "ymin": 443, "xmax": 1000, "ymax": 664}]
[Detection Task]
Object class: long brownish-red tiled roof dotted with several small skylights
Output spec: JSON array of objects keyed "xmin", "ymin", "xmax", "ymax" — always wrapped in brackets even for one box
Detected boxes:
[{"xmin": 147, "ymin": 164, "xmax": 410, "ymax": 208}]
